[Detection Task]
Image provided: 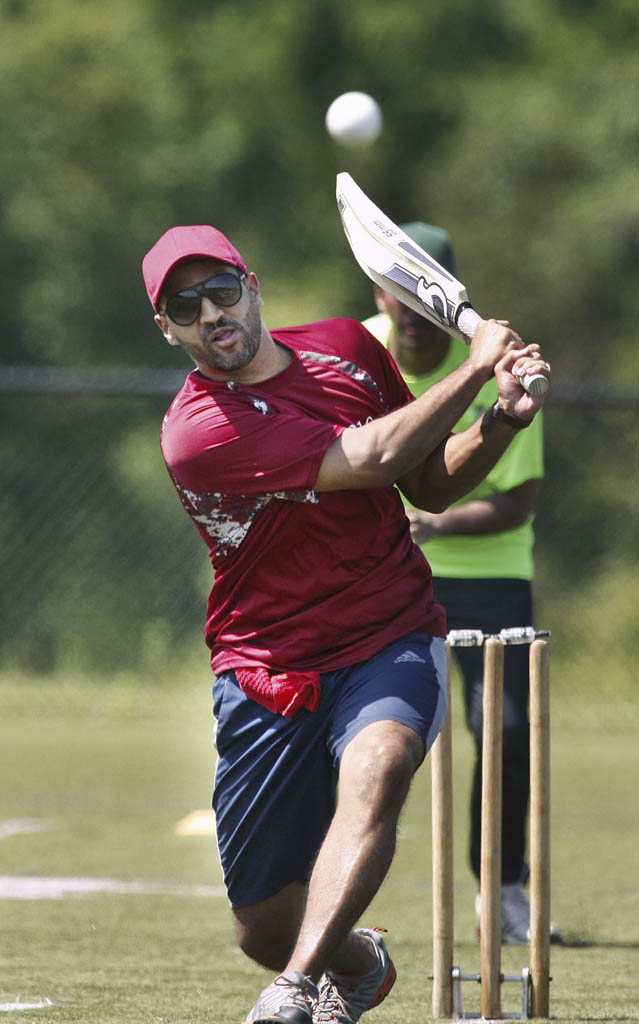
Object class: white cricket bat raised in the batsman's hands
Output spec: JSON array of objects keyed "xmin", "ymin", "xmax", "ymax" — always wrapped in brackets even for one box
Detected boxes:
[{"xmin": 337, "ymin": 171, "xmax": 548, "ymax": 395}]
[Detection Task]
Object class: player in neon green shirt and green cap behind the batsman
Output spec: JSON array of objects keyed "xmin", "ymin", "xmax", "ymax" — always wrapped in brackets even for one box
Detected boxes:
[{"xmin": 365, "ymin": 221, "xmax": 559, "ymax": 943}]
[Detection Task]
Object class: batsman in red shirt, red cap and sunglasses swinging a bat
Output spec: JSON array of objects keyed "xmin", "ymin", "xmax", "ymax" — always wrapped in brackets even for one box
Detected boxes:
[{"xmin": 142, "ymin": 225, "xmax": 547, "ymax": 1024}]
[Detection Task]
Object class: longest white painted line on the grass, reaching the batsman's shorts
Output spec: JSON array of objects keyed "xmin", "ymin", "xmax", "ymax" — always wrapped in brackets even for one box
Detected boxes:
[{"xmin": 0, "ymin": 874, "xmax": 224, "ymax": 899}]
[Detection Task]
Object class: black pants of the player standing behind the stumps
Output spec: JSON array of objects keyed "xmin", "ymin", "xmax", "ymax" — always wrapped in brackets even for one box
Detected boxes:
[{"xmin": 433, "ymin": 577, "xmax": 534, "ymax": 883}]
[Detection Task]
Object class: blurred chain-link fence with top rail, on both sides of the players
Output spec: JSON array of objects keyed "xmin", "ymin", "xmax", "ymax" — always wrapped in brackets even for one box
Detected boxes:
[{"xmin": 0, "ymin": 367, "xmax": 639, "ymax": 685}]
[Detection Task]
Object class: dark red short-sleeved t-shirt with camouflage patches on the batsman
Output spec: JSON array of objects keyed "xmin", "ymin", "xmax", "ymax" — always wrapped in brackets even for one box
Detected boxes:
[{"xmin": 162, "ymin": 318, "xmax": 445, "ymax": 672}]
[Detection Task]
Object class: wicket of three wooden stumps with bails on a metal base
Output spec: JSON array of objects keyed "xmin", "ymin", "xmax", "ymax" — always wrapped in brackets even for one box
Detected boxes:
[{"xmin": 431, "ymin": 627, "xmax": 550, "ymax": 1020}]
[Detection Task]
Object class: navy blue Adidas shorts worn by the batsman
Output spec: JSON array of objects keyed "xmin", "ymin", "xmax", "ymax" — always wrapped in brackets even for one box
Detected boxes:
[{"xmin": 213, "ymin": 633, "xmax": 445, "ymax": 906}]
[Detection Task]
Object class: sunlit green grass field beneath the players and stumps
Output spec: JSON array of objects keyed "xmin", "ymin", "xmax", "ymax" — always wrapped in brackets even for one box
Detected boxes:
[{"xmin": 0, "ymin": 673, "xmax": 639, "ymax": 1024}]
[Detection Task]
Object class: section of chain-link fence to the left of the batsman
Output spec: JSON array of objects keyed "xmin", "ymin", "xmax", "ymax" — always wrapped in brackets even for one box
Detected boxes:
[{"xmin": 0, "ymin": 371, "xmax": 206, "ymax": 673}]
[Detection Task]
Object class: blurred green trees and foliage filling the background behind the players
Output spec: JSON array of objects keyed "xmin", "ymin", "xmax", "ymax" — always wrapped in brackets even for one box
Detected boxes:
[{"xmin": 0, "ymin": 0, "xmax": 639, "ymax": 686}]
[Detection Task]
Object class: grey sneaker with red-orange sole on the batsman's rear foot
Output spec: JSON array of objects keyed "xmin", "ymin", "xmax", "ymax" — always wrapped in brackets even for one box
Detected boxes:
[{"xmin": 312, "ymin": 928, "xmax": 397, "ymax": 1024}]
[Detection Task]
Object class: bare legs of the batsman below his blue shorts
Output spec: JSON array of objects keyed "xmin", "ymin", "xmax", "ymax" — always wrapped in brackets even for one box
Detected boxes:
[{"xmin": 230, "ymin": 721, "xmax": 424, "ymax": 981}]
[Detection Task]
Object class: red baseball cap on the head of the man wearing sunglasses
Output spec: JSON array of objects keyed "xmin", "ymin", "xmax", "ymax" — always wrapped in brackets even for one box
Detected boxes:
[{"xmin": 142, "ymin": 224, "xmax": 249, "ymax": 310}]
